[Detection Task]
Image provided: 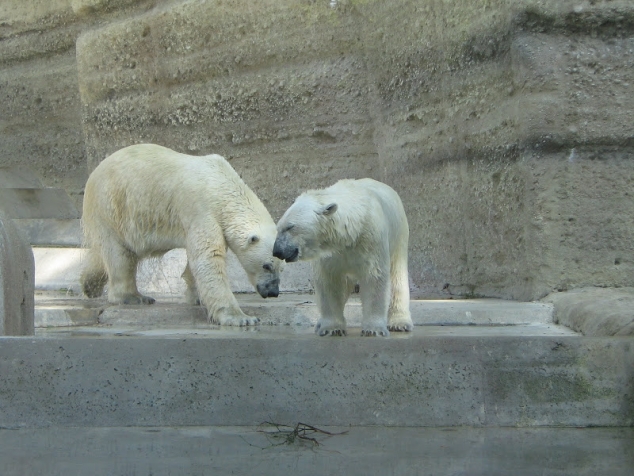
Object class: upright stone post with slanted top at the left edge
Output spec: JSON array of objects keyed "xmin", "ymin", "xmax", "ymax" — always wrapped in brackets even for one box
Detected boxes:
[{"xmin": 0, "ymin": 210, "xmax": 35, "ymax": 336}]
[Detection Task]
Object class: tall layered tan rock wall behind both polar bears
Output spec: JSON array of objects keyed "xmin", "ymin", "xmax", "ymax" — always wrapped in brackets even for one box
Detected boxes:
[{"xmin": 0, "ymin": 0, "xmax": 634, "ymax": 299}]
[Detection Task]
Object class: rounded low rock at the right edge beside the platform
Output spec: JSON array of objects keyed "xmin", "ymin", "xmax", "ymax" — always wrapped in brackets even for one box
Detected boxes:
[{"xmin": 542, "ymin": 288, "xmax": 634, "ymax": 336}]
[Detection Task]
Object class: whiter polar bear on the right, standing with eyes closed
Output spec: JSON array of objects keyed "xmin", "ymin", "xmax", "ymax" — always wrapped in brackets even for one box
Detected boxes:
[{"xmin": 273, "ymin": 178, "xmax": 413, "ymax": 336}]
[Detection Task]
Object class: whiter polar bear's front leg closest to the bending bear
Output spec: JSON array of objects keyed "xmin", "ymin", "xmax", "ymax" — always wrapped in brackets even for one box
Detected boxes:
[{"xmin": 314, "ymin": 260, "xmax": 350, "ymax": 336}]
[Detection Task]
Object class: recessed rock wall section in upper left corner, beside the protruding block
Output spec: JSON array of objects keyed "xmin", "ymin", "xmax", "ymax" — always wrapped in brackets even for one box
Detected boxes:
[{"xmin": 0, "ymin": 0, "xmax": 156, "ymax": 209}]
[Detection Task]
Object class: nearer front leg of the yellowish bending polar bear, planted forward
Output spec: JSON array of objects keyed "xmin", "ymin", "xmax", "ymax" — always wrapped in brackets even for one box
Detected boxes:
[{"xmin": 187, "ymin": 228, "xmax": 259, "ymax": 326}]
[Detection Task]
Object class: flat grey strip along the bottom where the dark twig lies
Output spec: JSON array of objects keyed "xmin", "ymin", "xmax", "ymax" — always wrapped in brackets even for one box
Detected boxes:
[{"xmin": 0, "ymin": 427, "xmax": 634, "ymax": 476}]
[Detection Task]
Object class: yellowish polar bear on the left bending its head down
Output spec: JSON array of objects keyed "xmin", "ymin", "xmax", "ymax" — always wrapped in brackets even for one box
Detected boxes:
[{"xmin": 81, "ymin": 144, "xmax": 281, "ymax": 325}]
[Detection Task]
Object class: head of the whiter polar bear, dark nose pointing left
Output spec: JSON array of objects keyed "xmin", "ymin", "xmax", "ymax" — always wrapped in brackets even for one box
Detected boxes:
[{"xmin": 273, "ymin": 191, "xmax": 339, "ymax": 262}]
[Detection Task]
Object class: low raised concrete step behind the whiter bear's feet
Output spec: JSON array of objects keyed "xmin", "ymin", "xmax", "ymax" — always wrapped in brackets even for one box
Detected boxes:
[{"xmin": 35, "ymin": 291, "xmax": 553, "ymax": 328}]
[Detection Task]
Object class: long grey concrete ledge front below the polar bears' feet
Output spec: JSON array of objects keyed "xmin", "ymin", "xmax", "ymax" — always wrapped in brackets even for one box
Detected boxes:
[{"xmin": 0, "ymin": 326, "xmax": 634, "ymax": 427}]
